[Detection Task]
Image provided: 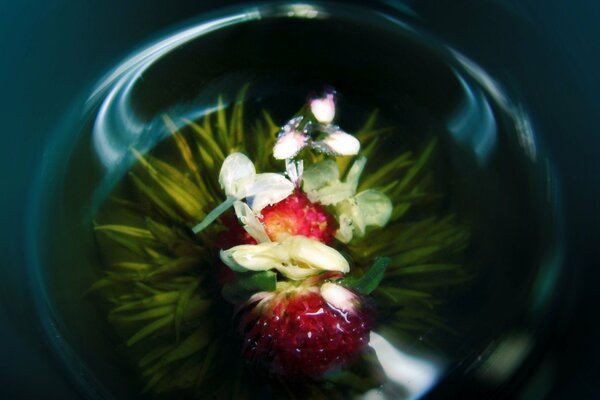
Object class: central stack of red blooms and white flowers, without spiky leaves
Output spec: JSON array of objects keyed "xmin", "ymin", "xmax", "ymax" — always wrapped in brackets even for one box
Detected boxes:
[{"xmin": 194, "ymin": 91, "xmax": 392, "ymax": 378}]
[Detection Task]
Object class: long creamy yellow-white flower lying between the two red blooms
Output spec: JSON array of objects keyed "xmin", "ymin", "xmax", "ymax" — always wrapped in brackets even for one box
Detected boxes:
[{"xmin": 221, "ymin": 236, "xmax": 350, "ymax": 280}]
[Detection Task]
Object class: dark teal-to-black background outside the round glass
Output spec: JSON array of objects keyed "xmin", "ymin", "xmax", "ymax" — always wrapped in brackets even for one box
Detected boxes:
[{"xmin": 0, "ymin": 0, "xmax": 600, "ymax": 399}]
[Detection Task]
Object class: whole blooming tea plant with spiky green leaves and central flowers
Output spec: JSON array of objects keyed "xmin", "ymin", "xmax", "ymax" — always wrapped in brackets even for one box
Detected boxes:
[{"xmin": 91, "ymin": 88, "xmax": 469, "ymax": 399}]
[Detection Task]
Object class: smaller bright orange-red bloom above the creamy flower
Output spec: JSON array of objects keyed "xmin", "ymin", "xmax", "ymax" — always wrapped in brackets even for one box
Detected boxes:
[{"xmin": 261, "ymin": 189, "xmax": 336, "ymax": 244}]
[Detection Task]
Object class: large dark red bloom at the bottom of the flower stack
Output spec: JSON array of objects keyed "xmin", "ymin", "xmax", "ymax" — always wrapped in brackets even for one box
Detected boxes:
[{"xmin": 240, "ymin": 286, "xmax": 372, "ymax": 379}]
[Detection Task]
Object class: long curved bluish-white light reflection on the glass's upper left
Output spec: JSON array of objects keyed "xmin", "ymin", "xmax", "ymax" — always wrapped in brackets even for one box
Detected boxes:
[{"xmin": 87, "ymin": 4, "xmax": 327, "ymax": 170}]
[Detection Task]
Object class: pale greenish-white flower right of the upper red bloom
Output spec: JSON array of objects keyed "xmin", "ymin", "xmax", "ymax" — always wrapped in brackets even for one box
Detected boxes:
[{"xmin": 303, "ymin": 157, "xmax": 393, "ymax": 243}]
